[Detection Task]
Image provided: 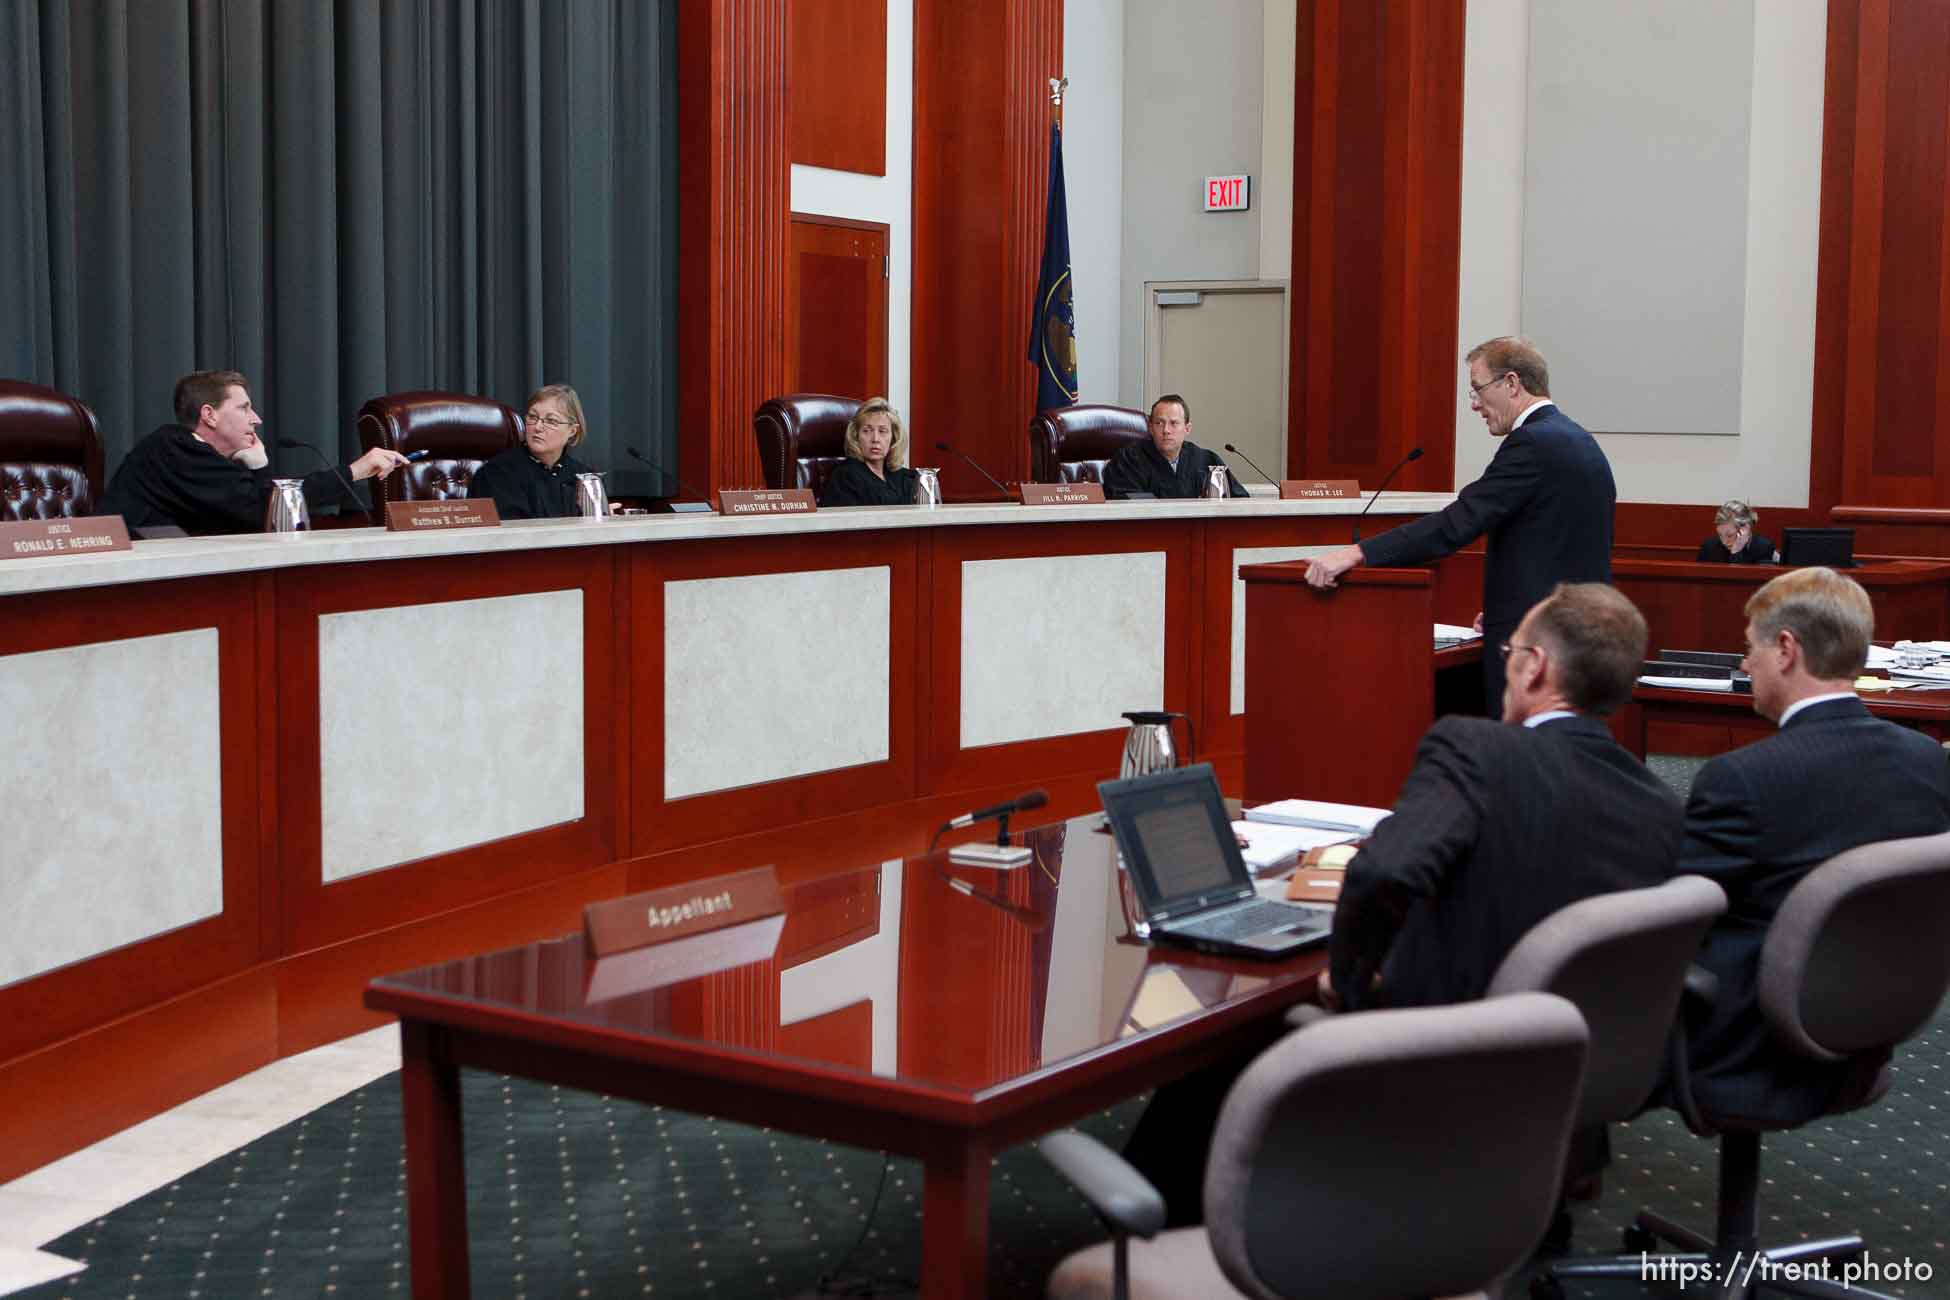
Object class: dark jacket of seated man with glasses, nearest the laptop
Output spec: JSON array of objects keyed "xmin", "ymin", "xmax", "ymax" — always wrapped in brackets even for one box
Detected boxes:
[{"xmin": 1328, "ymin": 717, "xmax": 1681, "ymax": 1010}]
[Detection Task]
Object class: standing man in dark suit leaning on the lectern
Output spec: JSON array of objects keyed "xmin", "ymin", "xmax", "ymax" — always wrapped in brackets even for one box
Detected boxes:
[{"xmin": 1307, "ymin": 337, "xmax": 1617, "ymax": 717}]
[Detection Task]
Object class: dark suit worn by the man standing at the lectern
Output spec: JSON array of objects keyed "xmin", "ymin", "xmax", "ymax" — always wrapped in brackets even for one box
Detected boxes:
[{"xmin": 1361, "ymin": 405, "xmax": 1619, "ymax": 701}]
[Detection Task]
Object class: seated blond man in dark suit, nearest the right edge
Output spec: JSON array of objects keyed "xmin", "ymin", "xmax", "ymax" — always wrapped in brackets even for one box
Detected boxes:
[{"xmin": 1679, "ymin": 569, "xmax": 1950, "ymax": 1125}]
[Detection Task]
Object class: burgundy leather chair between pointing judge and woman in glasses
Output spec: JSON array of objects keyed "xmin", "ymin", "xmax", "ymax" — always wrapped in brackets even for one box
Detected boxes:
[{"xmin": 357, "ymin": 390, "xmax": 521, "ymax": 509}]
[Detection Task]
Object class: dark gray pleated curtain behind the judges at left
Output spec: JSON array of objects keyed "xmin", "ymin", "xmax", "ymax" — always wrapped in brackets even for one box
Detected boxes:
[{"xmin": 0, "ymin": 0, "xmax": 677, "ymax": 472}]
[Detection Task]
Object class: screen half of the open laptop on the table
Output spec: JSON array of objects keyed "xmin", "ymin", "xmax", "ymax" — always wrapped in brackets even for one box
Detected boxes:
[{"xmin": 1098, "ymin": 762, "xmax": 1252, "ymax": 916}]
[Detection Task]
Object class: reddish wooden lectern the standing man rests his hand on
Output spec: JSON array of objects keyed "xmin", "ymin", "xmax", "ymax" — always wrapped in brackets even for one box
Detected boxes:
[{"xmin": 1238, "ymin": 561, "xmax": 1494, "ymax": 807}]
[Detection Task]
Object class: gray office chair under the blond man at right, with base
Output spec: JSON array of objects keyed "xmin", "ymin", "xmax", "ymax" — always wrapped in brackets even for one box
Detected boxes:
[{"xmin": 1533, "ymin": 834, "xmax": 1950, "ymax": 1300}]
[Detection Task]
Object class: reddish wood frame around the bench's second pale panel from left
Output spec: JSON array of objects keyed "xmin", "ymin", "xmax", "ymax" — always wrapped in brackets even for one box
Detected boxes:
[{"xmin": 277, "ymin": 548, "xmax": 622, "ymax": 953}]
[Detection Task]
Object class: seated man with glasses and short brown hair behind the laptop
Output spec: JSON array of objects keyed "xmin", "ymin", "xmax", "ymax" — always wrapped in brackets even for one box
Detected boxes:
[{"xmin": 1125, "ymin": 583, "xmax": 1681, "ymax": 1224}]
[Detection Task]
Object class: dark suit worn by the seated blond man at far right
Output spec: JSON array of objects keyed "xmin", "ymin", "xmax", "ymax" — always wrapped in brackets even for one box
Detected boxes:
[{"xmin": 1679, "ymin": 700, "xmax": 1950, "ymax": 1127}]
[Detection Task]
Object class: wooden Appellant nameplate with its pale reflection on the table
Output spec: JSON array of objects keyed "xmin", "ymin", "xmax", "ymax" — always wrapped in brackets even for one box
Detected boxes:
[{"xmin": 583, "ymin": 867, "xmax": 786, "ymax": 1002}]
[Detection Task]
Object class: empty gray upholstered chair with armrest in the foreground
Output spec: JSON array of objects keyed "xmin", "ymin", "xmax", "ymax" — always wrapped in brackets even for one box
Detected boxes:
[{"xmin": 1041, "ymin": 994, "xmax": 1587, "ymax": 1300}]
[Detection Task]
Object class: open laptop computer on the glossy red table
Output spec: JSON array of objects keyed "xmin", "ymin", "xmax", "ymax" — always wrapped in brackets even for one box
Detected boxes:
[{"xmin": 1098, "ymin": 762, "xmax": 1332, "ymax": 957}]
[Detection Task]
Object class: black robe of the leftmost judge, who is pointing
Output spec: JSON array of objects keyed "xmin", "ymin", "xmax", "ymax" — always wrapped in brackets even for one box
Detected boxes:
[{"xmin": 101, "ymin": 425, "xmax": 365, "ymax": 536}]
